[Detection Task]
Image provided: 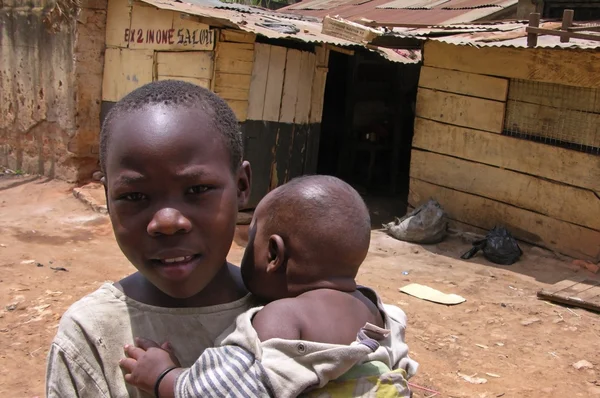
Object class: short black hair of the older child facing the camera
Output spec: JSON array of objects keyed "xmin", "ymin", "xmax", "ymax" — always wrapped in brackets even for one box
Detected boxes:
[{"xmin": 100, "ymin": 80, "xmax": 243, "ymax": 172}]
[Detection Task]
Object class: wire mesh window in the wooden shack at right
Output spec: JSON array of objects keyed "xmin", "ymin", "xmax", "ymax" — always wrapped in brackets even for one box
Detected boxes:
[{"xmin": 503, "ymin": 79, "xmax": 600, "ymax": 155}]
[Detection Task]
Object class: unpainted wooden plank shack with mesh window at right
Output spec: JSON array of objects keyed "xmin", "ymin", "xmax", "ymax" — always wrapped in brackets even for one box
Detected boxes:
[{"xmin": 409, "ymin": 23, "xmax": 600, "ymax": 262}]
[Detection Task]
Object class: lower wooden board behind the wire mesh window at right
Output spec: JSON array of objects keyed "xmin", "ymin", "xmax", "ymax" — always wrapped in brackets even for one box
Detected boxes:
[{"xmin": 506, "ymin": 101, "xmax": 600, "ymax": 148}]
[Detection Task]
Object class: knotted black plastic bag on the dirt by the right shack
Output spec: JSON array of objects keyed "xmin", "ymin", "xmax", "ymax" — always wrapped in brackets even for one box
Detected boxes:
[{"xmin": 460, "ymin": 226, "xmax": 523, "ymax": 265}]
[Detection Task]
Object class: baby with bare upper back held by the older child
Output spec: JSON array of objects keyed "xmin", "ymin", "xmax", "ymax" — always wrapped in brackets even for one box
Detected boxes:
[{"xmin": 121, "ymin": 176, "xmax": 416, "ymax": 398}]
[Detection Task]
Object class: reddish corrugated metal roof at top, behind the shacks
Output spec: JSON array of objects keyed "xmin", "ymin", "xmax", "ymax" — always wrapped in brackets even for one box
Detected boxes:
[{"xmin": 278, "ymin": 0, "xmax": 518, "ymax": 25}]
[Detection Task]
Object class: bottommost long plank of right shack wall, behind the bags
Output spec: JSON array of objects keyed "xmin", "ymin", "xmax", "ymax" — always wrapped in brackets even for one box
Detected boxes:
[{"xmin": 409, "ymin": 178, "xmax": 600, "ymax": 261}]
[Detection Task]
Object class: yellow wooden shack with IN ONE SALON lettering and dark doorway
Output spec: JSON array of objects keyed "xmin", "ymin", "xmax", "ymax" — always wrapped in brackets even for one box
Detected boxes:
[{"xmin": 102, "ymin": 0, "xmax": 421, "ymax": 207}]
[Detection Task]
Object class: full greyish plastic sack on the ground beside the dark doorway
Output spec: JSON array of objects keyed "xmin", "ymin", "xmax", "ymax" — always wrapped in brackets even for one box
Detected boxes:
[{"xmin": 383, "ymin": 199, "xmax": 448, "ymax": 244}]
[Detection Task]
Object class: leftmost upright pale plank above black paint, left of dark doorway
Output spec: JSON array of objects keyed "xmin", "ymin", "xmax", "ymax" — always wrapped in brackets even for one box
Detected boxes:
[{"xmin": 248, "ymin": 43, "xmax": 271, "ymax": 120}]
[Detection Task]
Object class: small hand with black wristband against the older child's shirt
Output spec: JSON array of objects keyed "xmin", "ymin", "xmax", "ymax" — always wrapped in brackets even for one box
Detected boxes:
[{"xmin": 119, "ymin": 337, "xmax": 181, "ymax": 394}]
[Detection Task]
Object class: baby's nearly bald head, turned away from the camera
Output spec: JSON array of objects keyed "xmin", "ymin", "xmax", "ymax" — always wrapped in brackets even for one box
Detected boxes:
[{"xmin": 242, "ymin": 176, "xmax": 371, "ymax": 300}]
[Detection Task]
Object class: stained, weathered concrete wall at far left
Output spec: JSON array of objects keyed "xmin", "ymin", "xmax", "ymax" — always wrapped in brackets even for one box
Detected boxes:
[{"xmin": 0, "ymin": 0, "xmax": 106, "ymax": 181}]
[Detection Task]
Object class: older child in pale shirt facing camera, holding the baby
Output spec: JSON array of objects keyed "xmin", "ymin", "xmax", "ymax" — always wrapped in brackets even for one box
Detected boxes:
[{"xmin": 46, "ymin": 81, "xmax": 252, "ymax": 398}]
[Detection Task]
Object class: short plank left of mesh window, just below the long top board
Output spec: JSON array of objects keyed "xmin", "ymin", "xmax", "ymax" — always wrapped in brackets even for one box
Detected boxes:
[{"xmin": 419, "ymin": 66, "xmax": 508, "ymax": 101}]
